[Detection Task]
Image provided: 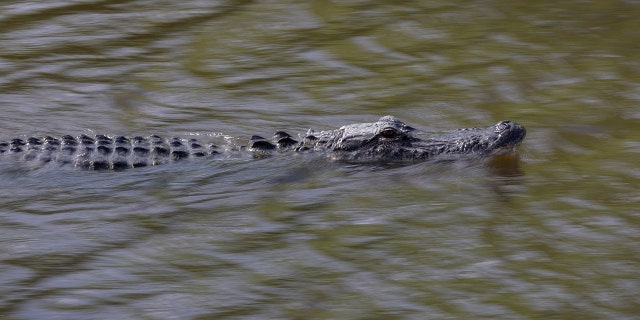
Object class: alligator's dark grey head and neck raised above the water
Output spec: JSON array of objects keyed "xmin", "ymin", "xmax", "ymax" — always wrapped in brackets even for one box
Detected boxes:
[{"xmin": 252, "ymin": 116, "xmax": 526, "ymax": 162}]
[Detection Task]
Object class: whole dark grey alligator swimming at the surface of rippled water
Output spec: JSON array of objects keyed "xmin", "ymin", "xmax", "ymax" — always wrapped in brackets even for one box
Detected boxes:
[{"xmin": 0, "ymin": 116, "xmax": 526, "ymax": 170}]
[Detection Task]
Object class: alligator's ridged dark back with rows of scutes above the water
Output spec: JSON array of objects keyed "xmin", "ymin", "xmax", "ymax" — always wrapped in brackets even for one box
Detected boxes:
[{"xmin": 0, "ymin": 134, "xmax": 218, "ymax": 170}]
